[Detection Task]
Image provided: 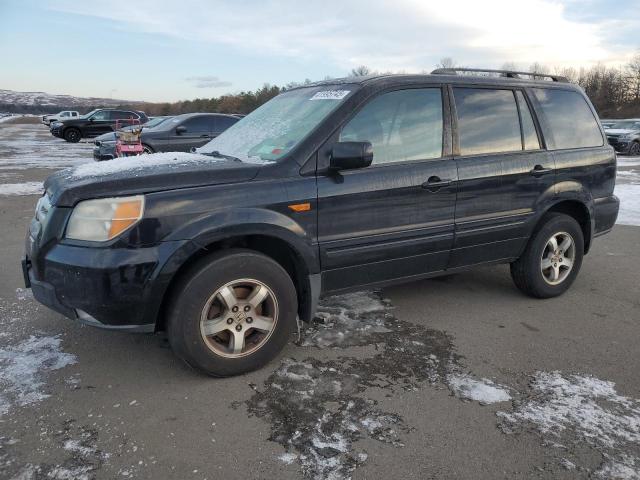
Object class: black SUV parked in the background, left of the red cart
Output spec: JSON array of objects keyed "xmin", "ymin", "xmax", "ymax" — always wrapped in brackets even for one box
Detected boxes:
[{"xmin": 51, "ymin": 108, "xmax": 148, "ymax": 143}]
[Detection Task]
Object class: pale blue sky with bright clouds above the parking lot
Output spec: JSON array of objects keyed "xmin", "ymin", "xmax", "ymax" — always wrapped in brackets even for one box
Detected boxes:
[{"xmin": 0, "ymin": 0, "xmax": 640, "ymax": 101}]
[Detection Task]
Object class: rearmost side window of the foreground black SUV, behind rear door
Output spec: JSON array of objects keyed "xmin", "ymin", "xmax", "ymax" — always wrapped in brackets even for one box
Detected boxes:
[{"xmin": 533, "ymin": 88, "xmax": 603, "ymax": 149}]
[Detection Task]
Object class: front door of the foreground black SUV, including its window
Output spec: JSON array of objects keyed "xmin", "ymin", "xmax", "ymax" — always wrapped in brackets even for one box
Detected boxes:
[{"xmin": 318, "ymin": 87, "xmax": 457, "ymax": 291}]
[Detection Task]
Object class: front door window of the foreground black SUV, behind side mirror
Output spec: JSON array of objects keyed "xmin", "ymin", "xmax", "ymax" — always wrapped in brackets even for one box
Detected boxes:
[{"xmin": 340, "ymin": 88, "xmax": 442, "ymax": 164}]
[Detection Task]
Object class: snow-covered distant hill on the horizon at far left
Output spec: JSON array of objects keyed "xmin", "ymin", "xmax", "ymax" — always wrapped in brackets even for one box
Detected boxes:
[{"xmin": 0, "ymin": 89, "xmax": 142, "ymax": 113}]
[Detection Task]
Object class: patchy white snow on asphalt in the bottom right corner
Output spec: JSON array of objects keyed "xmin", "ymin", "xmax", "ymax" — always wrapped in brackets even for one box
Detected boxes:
[{"xmin": 497, "ymin": 371, "xmax": 640, "ymax": 479}]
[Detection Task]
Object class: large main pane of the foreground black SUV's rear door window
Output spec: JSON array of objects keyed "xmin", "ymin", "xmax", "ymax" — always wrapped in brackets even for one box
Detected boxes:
[{"xmin": 453, "ymin": 88, "xmax": 522, "ymax": 155}]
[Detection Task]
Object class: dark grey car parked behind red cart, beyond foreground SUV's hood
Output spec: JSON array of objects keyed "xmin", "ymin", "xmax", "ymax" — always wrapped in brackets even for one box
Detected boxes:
[{"xmin": 93, "ymin": 113, "xmax": 240, "ymax": 160}]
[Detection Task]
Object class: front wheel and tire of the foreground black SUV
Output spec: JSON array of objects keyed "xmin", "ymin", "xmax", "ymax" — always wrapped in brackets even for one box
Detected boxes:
[{"xmin": 168, "ymin": 249, "xmax": 298, "ymax": 377}]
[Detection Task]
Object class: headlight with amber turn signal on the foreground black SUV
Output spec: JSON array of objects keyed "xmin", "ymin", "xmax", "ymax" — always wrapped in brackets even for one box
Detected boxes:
[{"xmin": 66, "ymin": 195, "xmax": 144, "ymax": 242}]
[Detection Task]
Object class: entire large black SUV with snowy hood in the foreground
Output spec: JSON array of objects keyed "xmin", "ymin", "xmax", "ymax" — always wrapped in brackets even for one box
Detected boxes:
[{"xmin": 23, "ymin": 70, "xmax": 619, "ymax": 376}]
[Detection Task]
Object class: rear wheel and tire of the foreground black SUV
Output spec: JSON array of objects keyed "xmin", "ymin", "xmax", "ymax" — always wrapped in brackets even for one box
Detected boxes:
[{"xmin": 511, "ymin": 212, "xmax": 584, "ymax": 298}]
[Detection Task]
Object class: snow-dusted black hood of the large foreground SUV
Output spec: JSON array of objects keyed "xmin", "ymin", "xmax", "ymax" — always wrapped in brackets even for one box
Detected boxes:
[{"xmin": 44, "ymin": 152, "xmax": 260, "ymax": 207}]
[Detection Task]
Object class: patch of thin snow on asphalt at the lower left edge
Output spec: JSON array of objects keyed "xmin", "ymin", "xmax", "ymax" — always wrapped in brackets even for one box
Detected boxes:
[{"xmin": 0, "ymin": 335, "xmax": 76, "ymax": 416}]
